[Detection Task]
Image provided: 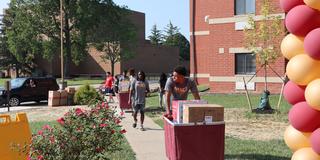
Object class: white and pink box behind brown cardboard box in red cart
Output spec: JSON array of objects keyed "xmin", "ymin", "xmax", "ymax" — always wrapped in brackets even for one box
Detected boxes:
[{"xmin": 172, "ymin": 100, "xmax": 208, "ymax": 123}]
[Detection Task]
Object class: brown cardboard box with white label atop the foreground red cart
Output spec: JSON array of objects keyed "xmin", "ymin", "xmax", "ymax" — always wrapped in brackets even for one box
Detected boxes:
[{"xmin": 183, "ymin": 104, "xmax": 224, "ymax": 123}]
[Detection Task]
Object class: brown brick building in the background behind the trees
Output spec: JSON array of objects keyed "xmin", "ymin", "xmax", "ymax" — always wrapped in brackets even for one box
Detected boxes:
[{"xmin": 37, "ymin": 11, "xmax": 180, "ymax": 77}]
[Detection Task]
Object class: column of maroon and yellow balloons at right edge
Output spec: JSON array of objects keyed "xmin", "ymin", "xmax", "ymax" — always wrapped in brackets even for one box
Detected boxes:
[{"xmin": 280, "ymin": 0, "xmax": 320, "ymax": 160}]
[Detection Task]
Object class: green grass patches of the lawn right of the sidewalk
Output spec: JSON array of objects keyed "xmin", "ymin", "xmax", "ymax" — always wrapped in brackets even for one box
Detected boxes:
[{"xmin": 146, "ymin": 86, "xmax": 292, "ymax": 160}]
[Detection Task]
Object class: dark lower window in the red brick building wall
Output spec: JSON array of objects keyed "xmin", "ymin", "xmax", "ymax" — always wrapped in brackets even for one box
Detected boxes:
[{"xmin": 235, "ymin": 53, "xmax": 256, "ymax": 74}]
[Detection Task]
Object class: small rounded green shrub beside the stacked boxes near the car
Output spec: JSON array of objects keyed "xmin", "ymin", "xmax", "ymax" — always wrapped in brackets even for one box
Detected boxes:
[{"xmin": 74, "ymin": 84, "xmax": 102, "ymax": 105}]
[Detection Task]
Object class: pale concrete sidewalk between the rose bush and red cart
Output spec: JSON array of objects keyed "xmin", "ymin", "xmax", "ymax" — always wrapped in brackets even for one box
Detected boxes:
[{"xmin": 110, "ymin": 101, "xmax": 167, "ymax": 160}]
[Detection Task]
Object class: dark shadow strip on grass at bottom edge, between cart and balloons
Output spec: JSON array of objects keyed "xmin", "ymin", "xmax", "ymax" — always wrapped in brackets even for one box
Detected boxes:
[{"xmin": 224, "ymin": 154, "xmax": 290, "ymax": 160}]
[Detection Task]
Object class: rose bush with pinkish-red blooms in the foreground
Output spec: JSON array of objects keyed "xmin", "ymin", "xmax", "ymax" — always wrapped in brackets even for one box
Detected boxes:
[{"xmin": 29, "ymin": 101, "xmax": 126, "ymax": 160}]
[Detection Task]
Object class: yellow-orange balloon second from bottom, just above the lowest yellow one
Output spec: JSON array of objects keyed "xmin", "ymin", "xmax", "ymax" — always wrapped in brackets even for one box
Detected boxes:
[{"xmin": 284, "ymin": 125, "xmax": 311, "ymax": 152}]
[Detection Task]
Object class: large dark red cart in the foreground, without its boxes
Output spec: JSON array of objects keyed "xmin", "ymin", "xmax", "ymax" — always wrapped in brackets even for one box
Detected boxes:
[{"xmin": 164, "ymin": 118, "xmax": 225, "ymax": 160}]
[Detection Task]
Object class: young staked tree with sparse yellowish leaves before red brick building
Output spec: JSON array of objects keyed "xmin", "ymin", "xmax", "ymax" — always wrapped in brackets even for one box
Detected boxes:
[{"xmin": 244, "ymin": 0, "xmax": 285, "ymax": 110}]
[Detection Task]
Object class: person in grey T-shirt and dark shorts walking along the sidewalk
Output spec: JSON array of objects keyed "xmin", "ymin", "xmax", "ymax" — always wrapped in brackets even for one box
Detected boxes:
[{"xmin": 128, "ymin": 71, "xmax": 150, "ymax": 131}]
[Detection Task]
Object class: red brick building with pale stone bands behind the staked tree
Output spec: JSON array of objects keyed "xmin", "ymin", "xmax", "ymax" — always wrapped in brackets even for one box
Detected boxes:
[{"xmin": 190, "ymin": 0, "xmax": 286, "ymax": 93}]
